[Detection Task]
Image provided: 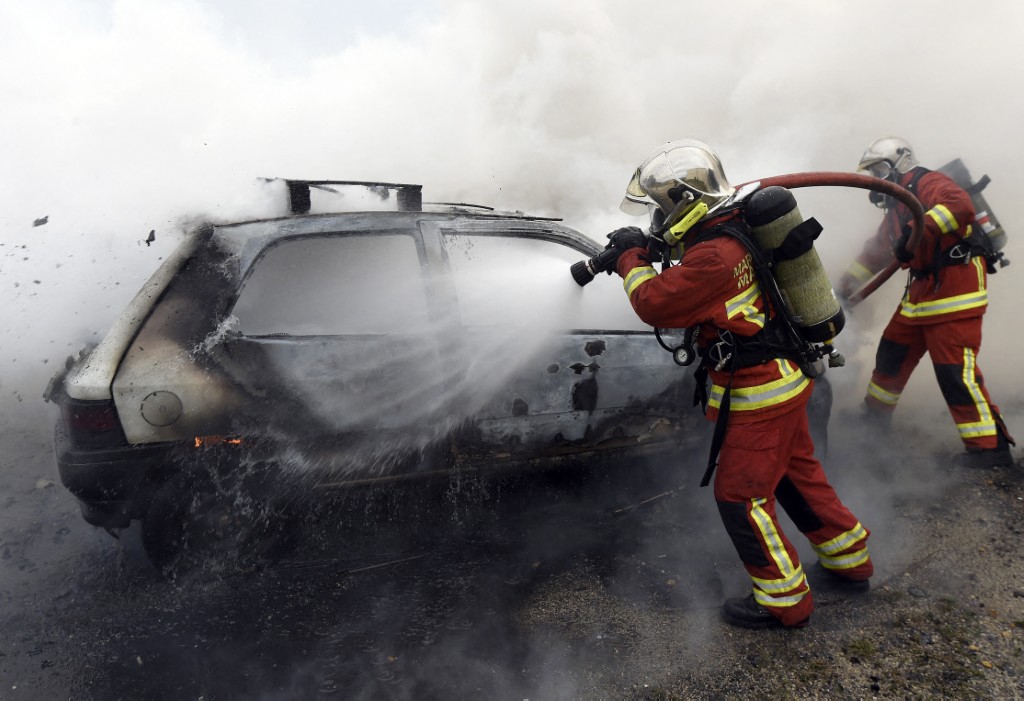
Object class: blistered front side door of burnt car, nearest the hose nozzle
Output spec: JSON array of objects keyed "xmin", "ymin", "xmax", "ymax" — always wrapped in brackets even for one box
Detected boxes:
[{"xmin": 424, "ymin": 220, "xmax": 692, "ymax": 455}]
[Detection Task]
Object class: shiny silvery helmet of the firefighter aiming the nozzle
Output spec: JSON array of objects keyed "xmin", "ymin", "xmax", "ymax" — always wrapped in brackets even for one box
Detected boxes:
[{"xmin": 620, "ymin": 139, "xmax": 733, "ymax": 224}]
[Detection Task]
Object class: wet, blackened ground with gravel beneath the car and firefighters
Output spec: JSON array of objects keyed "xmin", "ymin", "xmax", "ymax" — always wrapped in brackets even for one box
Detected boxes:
[{"xmin": 6, "ymin": 405, "xmax": 1024, "ymax": 700}]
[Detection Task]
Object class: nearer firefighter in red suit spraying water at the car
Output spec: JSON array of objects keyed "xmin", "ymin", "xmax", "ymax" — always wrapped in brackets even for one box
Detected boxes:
[{"xmin": 608, "ymin": 139, "xmax": 873, "ymax": 628}]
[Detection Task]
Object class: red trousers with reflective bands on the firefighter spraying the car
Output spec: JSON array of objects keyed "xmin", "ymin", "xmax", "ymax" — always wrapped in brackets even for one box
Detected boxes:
[{"xmin": 715, "ymin": 390, "xmax": 874, "ymax": 625}]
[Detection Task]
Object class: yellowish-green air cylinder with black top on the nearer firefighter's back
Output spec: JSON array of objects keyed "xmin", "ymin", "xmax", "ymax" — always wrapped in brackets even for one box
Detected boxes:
[{"xmin": 746, "ymin": 185, "xmax": 846, "ymax": 343}]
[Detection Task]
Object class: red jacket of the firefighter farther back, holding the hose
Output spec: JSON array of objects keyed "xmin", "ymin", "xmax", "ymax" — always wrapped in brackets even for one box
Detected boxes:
[{"xmin": 842, "ymin": 168, "xmax": 988, "ymax": 324}]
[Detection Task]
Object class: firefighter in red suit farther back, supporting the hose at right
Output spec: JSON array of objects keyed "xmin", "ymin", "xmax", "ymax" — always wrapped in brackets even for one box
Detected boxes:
[{"xmin": 839, "ymin": 137, "xmax": 1015, "ymax": 468}]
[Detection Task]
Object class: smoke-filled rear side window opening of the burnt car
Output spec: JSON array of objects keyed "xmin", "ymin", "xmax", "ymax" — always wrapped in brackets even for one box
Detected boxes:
[{"xmin": 231, "ymin": 232, "xmax": 429, "ymax": 336}]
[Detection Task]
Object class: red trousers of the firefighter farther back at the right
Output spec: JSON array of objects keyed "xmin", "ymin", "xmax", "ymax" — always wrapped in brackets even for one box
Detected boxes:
[{"xmin": 864, "ymin": 308, "xmax": 1013, "ymax": 448}]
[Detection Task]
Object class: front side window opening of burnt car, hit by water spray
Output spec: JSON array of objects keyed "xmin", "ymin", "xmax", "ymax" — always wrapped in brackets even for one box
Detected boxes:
[{"xmin": 441, "ymin": 231, "xmax": 649, "ymax": 331}]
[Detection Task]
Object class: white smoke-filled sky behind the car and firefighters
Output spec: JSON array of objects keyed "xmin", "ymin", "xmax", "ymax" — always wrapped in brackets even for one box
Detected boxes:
[{"xmin": 0, "ymin": 0, "xmax": 1024, "ymax": 434}]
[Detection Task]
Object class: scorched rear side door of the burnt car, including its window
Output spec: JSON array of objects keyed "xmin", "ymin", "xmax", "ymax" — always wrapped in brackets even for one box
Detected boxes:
[{"xmin": 218, "ymin": 229, "xmax": 442, "ymax": 454}]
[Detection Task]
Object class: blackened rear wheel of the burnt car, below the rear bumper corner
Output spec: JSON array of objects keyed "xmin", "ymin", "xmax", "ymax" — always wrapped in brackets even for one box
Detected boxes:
[{"xmin": 141, "ymin": 464, "xmax": 293, "ymax": 578}]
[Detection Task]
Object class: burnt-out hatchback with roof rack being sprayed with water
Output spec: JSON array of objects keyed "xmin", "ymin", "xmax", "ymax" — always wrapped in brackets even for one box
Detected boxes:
[{"xmin": 46, "ymin": 180, "xmax": 720, "ymax": 571}]
